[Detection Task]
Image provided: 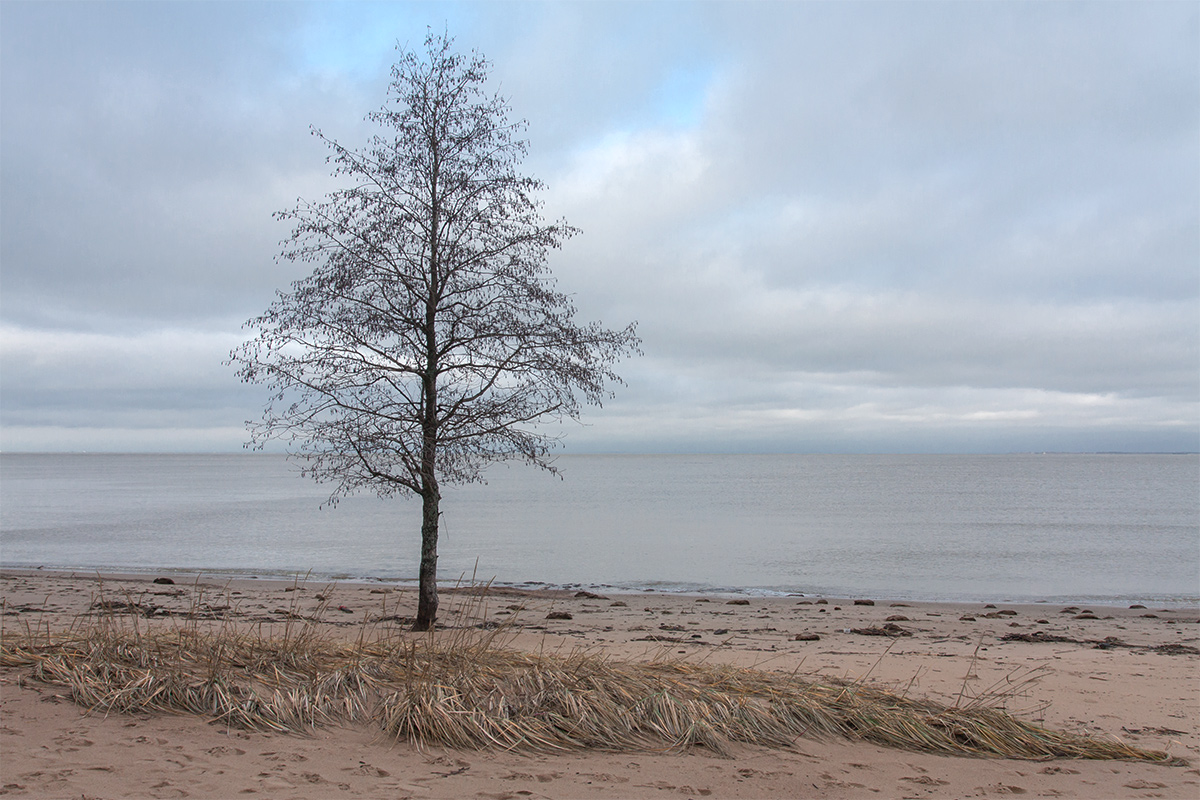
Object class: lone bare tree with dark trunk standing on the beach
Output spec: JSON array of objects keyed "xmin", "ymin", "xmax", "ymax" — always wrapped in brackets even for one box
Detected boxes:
[{"xmin": 230, "ymin": 34, "xmax": 640, "ymax": 630}]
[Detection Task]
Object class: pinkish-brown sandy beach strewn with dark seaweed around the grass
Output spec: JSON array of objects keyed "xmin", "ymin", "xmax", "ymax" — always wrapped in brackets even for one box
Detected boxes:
[{"xmin": 0, "ymin": 571, "xmax": 1200, "ymax": 800}]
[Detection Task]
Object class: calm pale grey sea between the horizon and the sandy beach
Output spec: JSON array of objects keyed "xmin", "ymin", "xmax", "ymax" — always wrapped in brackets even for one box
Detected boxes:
[{"xmin": 0, "ymin": 453, "xmax": 1200, "ymax": 602}]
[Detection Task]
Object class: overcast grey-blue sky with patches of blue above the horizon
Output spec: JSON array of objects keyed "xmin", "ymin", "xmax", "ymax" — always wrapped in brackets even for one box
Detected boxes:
[{"xmin": 0, "ymin": 0, "xmax": 1200, "ymax": 452}]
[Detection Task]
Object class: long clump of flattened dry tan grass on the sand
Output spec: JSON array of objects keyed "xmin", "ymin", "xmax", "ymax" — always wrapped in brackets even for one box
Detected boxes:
[{"xmin": 0, "ymin": 587, "xmax": 1180, "ymax": 763}]
